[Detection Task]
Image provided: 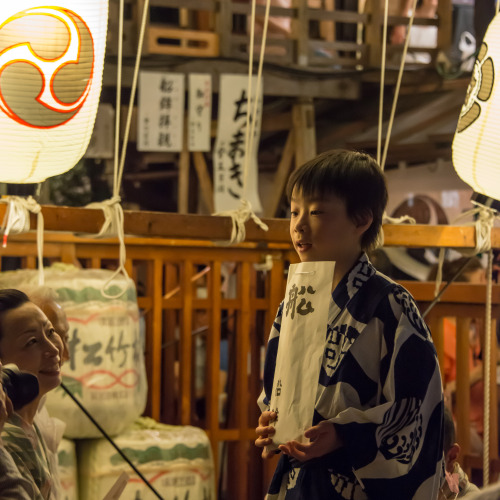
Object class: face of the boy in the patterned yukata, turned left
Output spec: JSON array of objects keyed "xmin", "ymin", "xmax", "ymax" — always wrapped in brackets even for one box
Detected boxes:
[{"xmin": 290, "ymin": 188, "xmax": 371, "ymax": 263}]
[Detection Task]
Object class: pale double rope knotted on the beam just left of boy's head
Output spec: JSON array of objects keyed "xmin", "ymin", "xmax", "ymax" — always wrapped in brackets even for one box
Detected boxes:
[{"xmin": 214, "ymin": 0, "xmax": 271, "ymax": 246}]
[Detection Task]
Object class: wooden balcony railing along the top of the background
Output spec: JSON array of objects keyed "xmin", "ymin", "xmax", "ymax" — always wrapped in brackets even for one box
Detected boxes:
[{"xmin": 114, "ymin": 0, "xmax": 452, "ymax": 71}]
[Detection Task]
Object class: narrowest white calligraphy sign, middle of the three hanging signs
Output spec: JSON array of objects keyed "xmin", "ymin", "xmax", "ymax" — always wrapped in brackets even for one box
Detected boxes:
[{"xmin": 188, "ymin": 73, "xmax": 212, "ymax": 151}]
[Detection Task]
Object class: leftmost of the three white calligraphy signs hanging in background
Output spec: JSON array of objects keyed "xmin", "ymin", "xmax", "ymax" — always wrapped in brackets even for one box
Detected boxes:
[{"xmin": 137, "ymin": 72, "xmax": 184, "ymax": 152}]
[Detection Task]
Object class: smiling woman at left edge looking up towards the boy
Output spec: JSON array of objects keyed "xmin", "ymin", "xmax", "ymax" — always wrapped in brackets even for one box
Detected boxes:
[{"xmin": 0, "ymin": 289, "xmax": 63, "ymax": 500}]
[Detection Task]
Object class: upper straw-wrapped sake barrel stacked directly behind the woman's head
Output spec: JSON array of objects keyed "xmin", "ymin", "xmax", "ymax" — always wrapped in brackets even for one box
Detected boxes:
[{"xmin": 0, "ymin": 266, "xmax": 147, "ymax": 439}]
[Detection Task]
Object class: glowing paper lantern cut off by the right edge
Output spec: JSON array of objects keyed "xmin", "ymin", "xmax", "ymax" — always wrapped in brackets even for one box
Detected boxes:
[{"xmin": 452, "ymin": 15, "xmax": 500, "ymax": 200}]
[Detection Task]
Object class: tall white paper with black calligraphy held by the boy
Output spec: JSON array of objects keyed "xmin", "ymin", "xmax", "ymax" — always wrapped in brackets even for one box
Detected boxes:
[{"xmin": 270, "ymin": 262, "xmax": 335, "ymax": 447}]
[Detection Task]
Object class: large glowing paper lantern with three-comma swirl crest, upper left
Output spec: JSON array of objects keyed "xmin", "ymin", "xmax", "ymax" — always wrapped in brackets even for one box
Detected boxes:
[{"xmin": 0, "ymin": 0, "xmax": 108, "ymax": 183}]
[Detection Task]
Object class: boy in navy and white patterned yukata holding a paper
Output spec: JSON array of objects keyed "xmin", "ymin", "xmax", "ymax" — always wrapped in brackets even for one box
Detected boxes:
[{"xmin": 255, "ymin": 151, "xmax": 443, "ymax": 500}]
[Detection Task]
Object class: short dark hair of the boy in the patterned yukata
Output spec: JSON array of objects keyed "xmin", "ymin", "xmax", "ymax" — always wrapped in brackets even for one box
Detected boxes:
[{"xmin": 286, "ymin": 149, "xmax": 387, "ymax": 250}]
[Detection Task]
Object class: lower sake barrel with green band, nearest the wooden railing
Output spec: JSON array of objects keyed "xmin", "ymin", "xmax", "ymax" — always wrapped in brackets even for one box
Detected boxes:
[{"xmin": 78, "ymin": 419, "xmax": 216, "ymax": 500}]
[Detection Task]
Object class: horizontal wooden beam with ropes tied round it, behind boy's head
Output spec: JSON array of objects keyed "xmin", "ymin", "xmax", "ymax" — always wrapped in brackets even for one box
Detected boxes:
[{"xmin": 0, "ymin": 204, "xmax": 500, "ymax": 248}]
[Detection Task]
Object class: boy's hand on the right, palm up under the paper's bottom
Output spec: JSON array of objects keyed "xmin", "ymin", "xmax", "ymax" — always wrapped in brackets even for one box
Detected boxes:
[{"xmin": 279, "ymin": 420, "xmax": 342, "ymax": 462}]
